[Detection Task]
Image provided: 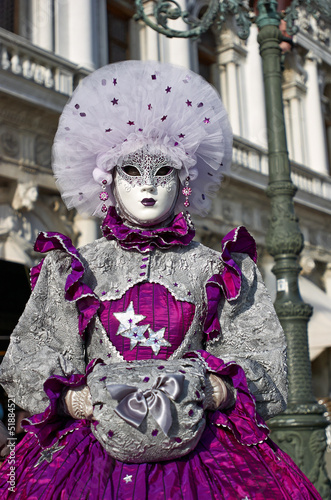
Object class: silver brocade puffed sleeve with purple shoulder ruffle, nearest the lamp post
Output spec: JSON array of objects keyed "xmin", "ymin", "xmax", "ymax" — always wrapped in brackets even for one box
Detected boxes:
[{"xmin": 205, "ymin": 229, "xmax": 287, "ymax": 419}]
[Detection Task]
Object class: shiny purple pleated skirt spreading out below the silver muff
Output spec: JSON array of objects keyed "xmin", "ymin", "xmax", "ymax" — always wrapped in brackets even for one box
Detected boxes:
[{"xmin": 0, "ymin": 421, "xmax": 321, "ymax": 500}]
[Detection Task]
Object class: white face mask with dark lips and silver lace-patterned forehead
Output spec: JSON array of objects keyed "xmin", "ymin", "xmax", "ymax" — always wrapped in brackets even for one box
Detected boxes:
[{"xmin": 114, "ymin": 149, "xmax": 179, "ymax": 226}]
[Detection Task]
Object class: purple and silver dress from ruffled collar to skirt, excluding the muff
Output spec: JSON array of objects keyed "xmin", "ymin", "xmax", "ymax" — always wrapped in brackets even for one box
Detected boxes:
[{"xmin": 0, "ymin": 207, "xmax": 320, "ymax": 500}]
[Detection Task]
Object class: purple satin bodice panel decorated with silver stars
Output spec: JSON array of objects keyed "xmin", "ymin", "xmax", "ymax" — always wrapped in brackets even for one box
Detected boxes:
[{"xmin": 99, "ymin": 283, "xmax": 195, "ymax": 361}]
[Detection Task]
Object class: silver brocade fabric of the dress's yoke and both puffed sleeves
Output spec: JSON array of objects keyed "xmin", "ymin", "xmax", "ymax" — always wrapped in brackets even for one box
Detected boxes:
[{"xmin": 0, "ymin": 238, "xmax": 286, "ymax": 418}]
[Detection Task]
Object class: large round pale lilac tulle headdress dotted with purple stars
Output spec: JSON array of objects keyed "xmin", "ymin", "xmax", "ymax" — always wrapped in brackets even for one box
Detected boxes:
[{"xmin": 53, "ymin": 61, "xmax": 232, "ymax": 217}]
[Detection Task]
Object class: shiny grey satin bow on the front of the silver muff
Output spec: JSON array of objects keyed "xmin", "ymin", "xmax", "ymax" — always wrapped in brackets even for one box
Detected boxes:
[{"xmin": 106, "ymin": 373, "xmax": 185, "ymax": 436}]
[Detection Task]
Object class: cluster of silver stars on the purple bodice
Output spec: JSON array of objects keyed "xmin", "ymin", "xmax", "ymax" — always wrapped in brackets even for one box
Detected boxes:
[{"xmin": 113, "ymin": 301, "xmax": 171, "ymax": 355}]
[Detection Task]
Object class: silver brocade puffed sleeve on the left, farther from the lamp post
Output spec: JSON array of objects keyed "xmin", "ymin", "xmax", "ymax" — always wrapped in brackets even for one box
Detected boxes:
[{"xmin": 0, "ymin": 233, "xmax": 99, "ymax": 414}]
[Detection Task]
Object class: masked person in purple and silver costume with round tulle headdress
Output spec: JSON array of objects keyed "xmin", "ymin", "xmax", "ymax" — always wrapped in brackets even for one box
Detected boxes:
[{"xmin": 1, "ymin": 61, "xmax": 320, "ymax": 500}]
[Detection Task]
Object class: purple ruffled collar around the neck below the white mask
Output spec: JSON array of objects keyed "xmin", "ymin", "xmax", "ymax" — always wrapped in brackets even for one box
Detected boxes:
[{"xmin": 101, "ymin": 207, "xmax": 195, "ymax": 253}]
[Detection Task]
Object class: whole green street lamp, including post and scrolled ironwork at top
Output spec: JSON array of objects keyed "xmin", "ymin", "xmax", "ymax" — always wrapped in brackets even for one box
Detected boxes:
[{"xmin": 136, "ymin": 0, "xmax": 331, "ymax": 499}]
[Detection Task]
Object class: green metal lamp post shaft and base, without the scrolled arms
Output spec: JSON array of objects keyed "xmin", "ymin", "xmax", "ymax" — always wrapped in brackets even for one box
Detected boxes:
[{"xmin": 256, "ymin": 0, "xmax": 330, "ymax": 498}]
